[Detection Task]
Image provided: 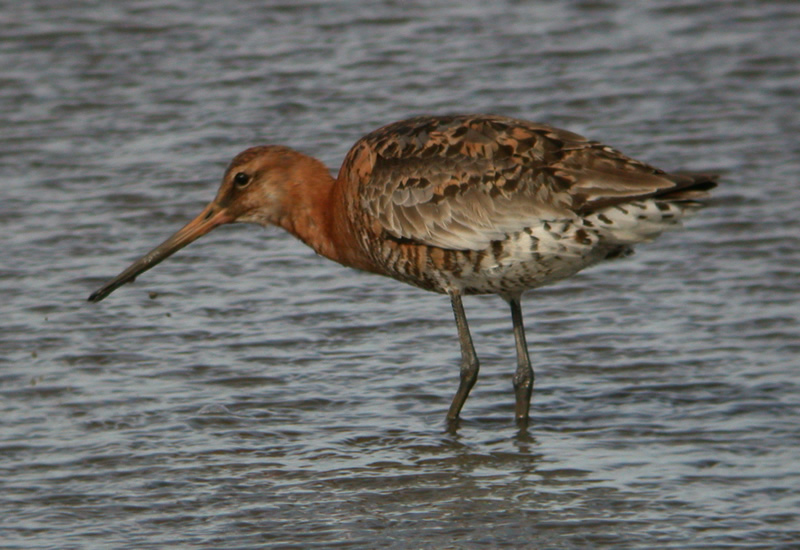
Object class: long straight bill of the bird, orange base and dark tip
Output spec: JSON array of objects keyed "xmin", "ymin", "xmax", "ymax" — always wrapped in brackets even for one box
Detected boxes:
[{"xmin": 89, "ymin": 202, "xmax": 233, "ymax": 302}]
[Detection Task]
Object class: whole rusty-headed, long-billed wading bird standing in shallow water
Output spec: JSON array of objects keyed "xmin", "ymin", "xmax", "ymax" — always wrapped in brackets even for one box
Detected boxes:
[{"xmin": 89, "ymin": 114, "xmax": 718, "ymax": 423}]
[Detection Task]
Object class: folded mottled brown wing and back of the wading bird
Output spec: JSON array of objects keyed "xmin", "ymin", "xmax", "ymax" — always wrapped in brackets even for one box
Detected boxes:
[{"xmin": 343, "ymin": 116, "xmax": 708, "ymax": 254}]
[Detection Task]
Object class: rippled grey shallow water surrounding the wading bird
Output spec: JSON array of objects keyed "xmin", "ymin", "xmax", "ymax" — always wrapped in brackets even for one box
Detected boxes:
[{"xmin": 0, "ymin": 0, "xmax": 800, "ymax": 549}]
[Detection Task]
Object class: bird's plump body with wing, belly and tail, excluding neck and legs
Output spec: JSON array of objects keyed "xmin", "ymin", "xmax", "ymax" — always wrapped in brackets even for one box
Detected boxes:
[{"xmin": 337, "ymin": 115, "xmax": 715, "ymax": 294}]
